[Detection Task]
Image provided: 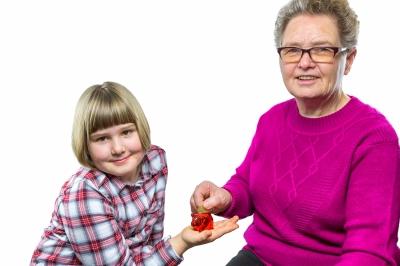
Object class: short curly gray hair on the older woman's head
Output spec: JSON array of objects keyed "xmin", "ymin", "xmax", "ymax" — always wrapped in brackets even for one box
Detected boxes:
[{"xmin": 274, "ymin": 0, "xmax": 360, "ymax": 48}]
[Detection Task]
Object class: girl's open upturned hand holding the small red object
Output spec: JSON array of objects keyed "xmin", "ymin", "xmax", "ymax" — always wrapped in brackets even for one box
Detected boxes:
[{"xmin": 169, "ymin": 216, "xmax": 239, "ymax": 256}]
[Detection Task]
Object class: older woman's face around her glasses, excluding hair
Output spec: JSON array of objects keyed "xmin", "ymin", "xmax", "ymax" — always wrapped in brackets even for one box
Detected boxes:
[{"xmin": 280, "ymin": 15, "xmax": 355, "ymax": 100}]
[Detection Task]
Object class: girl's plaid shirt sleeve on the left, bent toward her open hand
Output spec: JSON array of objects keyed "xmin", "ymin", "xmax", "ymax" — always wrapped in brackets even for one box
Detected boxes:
[{"xmin": 59, "ymin": 182, "xmax": 181, "ymax": 265}]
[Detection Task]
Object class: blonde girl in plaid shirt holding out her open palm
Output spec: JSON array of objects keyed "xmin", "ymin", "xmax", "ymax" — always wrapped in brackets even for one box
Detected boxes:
[{"xmin": 31, "ymin": 82, "xmax": 238, "ymax": 265}]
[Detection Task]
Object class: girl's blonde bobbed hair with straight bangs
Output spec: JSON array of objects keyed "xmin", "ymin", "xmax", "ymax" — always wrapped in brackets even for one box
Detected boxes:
[{"xmin": 72, "ymin": 81, "xmax": 151, "ymax": 167}]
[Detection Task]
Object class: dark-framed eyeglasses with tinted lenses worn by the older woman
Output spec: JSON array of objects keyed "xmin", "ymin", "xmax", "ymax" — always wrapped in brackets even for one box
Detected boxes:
[{"xmin": 277, "ymin": 46, "xmax": 348, "ymax": 63}]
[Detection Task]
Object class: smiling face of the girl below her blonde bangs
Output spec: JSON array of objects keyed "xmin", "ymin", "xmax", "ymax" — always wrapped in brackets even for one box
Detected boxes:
[{"xmin": 89, "ymin": 123, "xmax": 144, "ymax": 182}]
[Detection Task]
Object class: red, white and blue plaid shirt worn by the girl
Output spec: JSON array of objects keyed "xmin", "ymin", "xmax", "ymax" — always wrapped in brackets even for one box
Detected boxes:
[{"xmin": 31, "ymin": 146, "xmax": 182, "ymax": 266}]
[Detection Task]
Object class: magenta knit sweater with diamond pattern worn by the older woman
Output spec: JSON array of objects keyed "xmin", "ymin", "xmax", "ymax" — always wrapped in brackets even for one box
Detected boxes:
[{"xmin": 222, "ymin": 97, "xmax": 400, "ymax": 266}]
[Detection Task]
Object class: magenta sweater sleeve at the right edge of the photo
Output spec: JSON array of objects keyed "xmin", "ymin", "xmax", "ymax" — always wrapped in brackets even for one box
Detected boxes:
[{"xmin": 337, "ymin": 130, "xmax": 400, "ymax": 266}]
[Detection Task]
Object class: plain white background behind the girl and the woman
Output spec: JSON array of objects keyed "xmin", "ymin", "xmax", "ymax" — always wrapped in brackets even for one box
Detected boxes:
[{"xmin": 0, "ymin": 0, "xmax": 400, "ymax": 265}]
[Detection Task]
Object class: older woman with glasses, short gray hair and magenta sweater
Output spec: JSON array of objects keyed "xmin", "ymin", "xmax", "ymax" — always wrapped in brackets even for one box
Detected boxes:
[{"xmin": 191, "ymin": 0, "xmax": 400, "ymax": 266}]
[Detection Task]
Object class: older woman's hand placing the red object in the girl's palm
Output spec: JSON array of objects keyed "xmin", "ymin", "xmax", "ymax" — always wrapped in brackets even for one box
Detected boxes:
[{"xmin": 190, "ymin": 181, "xmax": 232, "ymax": 213}]
